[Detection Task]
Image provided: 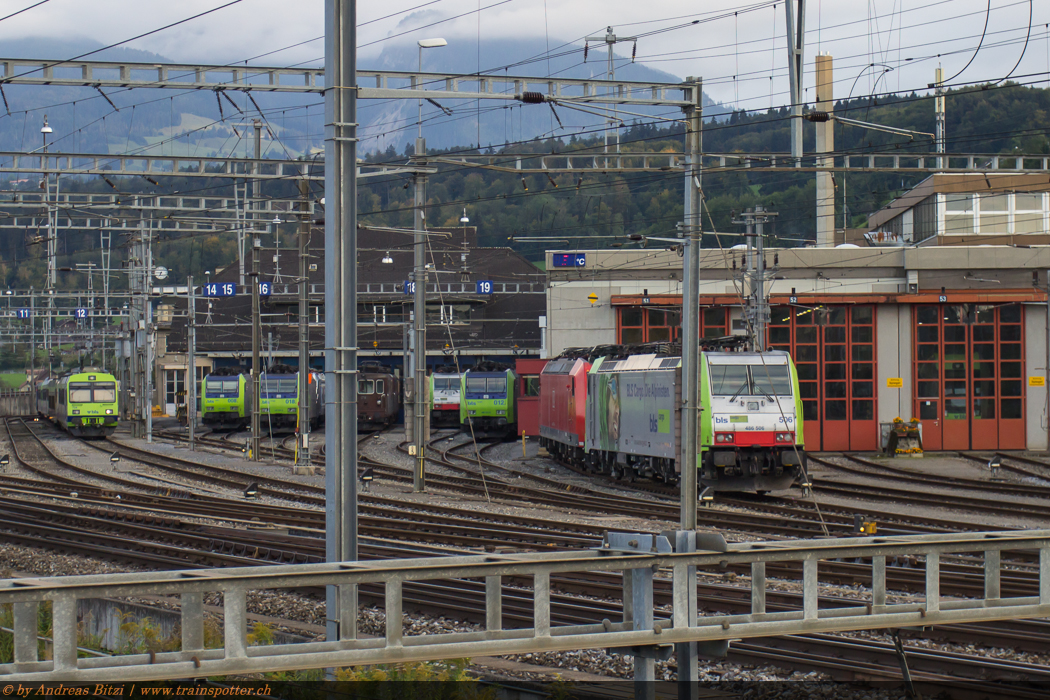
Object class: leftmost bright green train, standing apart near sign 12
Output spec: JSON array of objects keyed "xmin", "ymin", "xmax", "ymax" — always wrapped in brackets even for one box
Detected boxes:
[{"xmin": 36, "ymin": 367, "xmax": 120, "ymax": 438}]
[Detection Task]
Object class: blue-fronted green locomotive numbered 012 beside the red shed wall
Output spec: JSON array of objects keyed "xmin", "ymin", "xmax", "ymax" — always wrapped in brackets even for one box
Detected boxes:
[{"xmin": 460, "ymin": 363, "xmax": 518, "ymax": 438}]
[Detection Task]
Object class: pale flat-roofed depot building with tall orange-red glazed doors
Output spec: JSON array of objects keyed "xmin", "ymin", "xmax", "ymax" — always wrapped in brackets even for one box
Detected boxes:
[{"xmin": 546, "ymin": 243, "xmax": 1050, "ymax": 451}]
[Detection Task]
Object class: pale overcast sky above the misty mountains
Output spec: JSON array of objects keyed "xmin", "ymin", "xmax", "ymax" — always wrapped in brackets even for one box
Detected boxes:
[{"xmin": 0, "ymin": 0, "xmax": 1050, "ymax": 109}]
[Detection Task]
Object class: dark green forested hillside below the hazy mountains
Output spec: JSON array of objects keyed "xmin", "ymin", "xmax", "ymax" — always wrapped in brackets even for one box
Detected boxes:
[{"xmin": 0, "ymin": 80, "xmax": 1050, "ymax": 289}]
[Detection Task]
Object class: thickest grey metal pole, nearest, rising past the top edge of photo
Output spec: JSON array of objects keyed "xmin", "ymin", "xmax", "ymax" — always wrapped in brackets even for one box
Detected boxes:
[{"xmin": 324, "ymin": 0, "xmax": 357, "ymax": 654}]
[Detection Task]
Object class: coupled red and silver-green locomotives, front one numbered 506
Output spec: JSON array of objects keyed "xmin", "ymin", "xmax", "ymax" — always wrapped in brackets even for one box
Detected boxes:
[{"xmin": 540, "ymin": 339, "xmax": 805, "ymax": 492}]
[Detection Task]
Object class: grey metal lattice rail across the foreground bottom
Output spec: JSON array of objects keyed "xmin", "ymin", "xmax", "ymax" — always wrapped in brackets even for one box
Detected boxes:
[{"xmin": 0, "ymin": 530, "xmax": 1050, "ymax": 682}]
